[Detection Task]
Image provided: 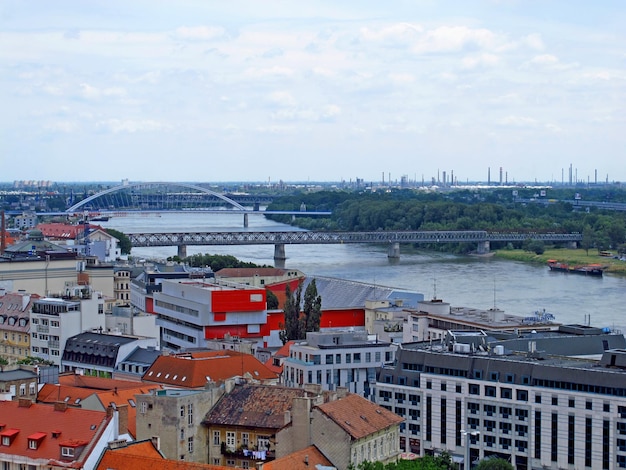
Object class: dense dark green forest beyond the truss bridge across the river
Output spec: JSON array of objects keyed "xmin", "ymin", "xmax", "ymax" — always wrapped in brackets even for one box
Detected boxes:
[{"xmin": 267, "ymin": 188, "xmax": 626, "ymax": 253}]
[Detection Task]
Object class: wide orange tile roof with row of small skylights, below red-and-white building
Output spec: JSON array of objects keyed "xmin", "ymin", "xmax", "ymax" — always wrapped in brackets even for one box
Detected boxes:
[{"xmin": 142, "ymin": 351, "xmax": 278, "ymax": 388}]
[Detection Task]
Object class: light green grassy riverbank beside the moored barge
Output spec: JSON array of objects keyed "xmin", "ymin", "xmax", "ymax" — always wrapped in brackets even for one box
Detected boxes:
[{"xmin": 495, "ymin": 248, "xmax": 626, "ymax": 275}]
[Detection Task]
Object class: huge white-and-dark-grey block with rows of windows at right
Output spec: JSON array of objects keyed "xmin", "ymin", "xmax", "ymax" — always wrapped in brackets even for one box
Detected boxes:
[{"xmin": 375, "ymin": 325, "xmax": 626, "ymax": 470}]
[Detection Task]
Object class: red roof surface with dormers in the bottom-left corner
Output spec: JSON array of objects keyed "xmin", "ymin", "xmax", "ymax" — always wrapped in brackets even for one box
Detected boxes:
[{"xmin": 0, "ymin": 400, "xmax": 111, "ymax": 468}]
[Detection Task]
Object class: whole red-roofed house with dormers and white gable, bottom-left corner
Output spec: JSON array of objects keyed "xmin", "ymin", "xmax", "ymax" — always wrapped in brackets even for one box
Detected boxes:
[{"xmin": 0, "ymin": 399, "xmax": 119, "ymax": 470}]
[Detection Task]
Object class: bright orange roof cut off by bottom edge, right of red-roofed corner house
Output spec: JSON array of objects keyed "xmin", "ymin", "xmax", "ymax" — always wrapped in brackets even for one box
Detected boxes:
[{"xmin": 95, "ymin": 441, "xmax": 232, "ymax": 470}]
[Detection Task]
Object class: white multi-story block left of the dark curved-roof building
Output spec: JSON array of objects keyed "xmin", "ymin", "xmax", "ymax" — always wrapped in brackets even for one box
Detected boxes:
[{"xmin": 30, "ymin": 286, "xmax": 105, "ymax": 366}]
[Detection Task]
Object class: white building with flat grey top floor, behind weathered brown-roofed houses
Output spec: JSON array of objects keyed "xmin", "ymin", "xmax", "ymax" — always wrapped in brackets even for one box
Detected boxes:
[{"xmin": 281, "ymin": 331, "xmax": 396, "ymax": 398}]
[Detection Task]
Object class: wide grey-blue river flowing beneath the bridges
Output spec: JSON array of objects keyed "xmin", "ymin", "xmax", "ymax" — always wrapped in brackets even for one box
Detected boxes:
[{"xmin": 99, "ymin": 213, "xmax": 626, "ymax": 332}]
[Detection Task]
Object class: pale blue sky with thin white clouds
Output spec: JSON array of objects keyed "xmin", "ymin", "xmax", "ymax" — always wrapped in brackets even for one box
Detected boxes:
[{"xmin": 0, "ymin": 0, "xmax": 626, "ymax": 184}]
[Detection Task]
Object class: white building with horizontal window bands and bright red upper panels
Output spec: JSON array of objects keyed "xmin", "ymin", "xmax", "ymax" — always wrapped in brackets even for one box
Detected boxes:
[{"xmin": 154, "ymin": 281, "xmax": 267, "ymax": 350}]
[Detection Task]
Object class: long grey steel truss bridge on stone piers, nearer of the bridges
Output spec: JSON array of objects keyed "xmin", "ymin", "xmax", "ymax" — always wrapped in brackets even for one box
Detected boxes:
[{"xmin": 127, "ymin": 230, "xmax": 582, "ymax": 260}]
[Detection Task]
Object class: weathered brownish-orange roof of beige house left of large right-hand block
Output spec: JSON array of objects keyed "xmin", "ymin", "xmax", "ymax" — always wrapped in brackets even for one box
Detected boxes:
[{"xmin": 317, "ymin": 393, "xmax": 404, "ymax": 439}]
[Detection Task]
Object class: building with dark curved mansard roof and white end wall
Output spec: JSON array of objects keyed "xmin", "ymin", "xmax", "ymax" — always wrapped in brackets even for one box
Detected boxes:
[{"xmin": 61, "ymin": 332, "xmax": 157, "ymax": 377}]
